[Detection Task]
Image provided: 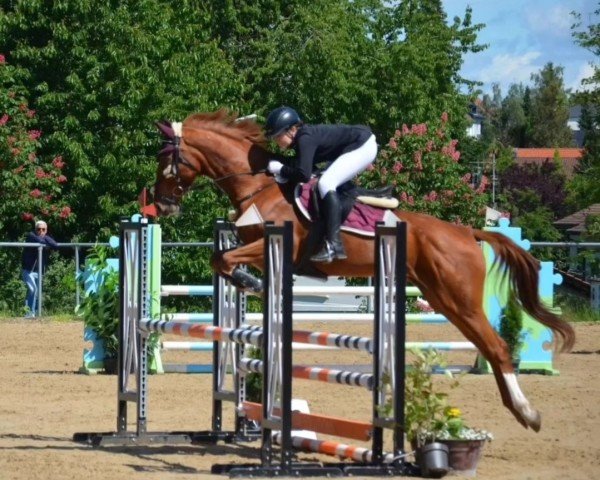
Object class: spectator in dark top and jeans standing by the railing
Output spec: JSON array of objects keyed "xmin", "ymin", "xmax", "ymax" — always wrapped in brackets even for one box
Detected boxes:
[{"xmin": 22, "ymin": 220, "xmax": 58, "ymax": 318}]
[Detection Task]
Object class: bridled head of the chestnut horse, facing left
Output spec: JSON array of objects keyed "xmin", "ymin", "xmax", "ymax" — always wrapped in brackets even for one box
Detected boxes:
[{"xmin": 154, "ymin": 122, "xmax": 201, "ymax": 216}]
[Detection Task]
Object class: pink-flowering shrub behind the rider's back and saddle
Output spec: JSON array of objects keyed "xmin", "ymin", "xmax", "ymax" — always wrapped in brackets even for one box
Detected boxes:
[{"xmin": 358, "ymin": 114, "xmax": 489, "ymax": 225}]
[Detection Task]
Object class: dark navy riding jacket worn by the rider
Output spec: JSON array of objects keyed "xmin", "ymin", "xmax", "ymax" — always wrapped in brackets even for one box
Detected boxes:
[{"xmin": 281, "ymin": 125, "xmax": 372, "ymax": 183}]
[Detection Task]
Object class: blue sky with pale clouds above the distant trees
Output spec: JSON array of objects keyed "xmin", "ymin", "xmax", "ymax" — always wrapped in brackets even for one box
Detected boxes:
[{"xmin": 442, "ymin": 0, "xmax": 600, "ymax": 96}]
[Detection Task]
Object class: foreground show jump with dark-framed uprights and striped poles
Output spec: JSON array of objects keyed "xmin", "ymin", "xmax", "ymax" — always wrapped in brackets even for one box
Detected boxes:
[{"xmin": 74, "ymin": 222, "xmax": 414, "ymax": 477}]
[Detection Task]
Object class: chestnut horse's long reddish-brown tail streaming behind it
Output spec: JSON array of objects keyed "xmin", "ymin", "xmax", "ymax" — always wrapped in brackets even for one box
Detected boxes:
[{"xmin": 473, "ymin": 230, "xmax": 575, "ymax": 352}]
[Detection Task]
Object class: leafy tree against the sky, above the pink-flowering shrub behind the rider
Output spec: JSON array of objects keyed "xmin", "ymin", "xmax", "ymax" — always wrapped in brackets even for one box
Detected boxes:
[{"xmin": 372, "ymin": 0, "xmax": 485, "ymax": 139}]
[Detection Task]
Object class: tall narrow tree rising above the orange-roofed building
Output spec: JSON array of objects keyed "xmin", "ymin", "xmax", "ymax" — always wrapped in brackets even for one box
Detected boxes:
[{"xmin": 530, "ymin": 63, "xmax": 573, "ymax": 148}]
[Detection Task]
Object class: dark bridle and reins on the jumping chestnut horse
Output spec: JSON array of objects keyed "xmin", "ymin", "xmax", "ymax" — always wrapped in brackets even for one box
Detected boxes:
[{"xmin": 155, "ymin": 122, "xmax": 277, "ymax": 205}]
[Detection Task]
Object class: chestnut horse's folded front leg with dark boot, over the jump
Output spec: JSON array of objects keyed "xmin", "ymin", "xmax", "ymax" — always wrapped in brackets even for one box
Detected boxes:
[{"xmin": 211, "ymin": 238, "xmax": 264, "ymax": 293}]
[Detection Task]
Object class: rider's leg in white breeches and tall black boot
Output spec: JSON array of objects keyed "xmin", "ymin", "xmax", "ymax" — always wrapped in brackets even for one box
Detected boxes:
[{"xmin": 311, "ymin": 135, "xmax": 377, "ymax": 262}]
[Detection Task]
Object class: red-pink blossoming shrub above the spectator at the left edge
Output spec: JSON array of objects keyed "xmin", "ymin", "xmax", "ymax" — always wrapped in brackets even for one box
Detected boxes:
[{"xmin": 0, "ymin": 55, "xmax": 72, "ymax": 237}]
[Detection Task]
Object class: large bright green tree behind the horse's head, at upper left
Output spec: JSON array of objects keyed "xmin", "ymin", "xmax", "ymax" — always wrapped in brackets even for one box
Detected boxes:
[{"xmin": 0, "ymin": 0, "xmax": 241, "ymax": 240}]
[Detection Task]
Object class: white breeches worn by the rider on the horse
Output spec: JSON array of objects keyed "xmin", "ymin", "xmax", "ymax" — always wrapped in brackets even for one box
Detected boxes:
[{"xmin": 319, "ymin": 135, "xmax": 377, "ymax": 198}]
